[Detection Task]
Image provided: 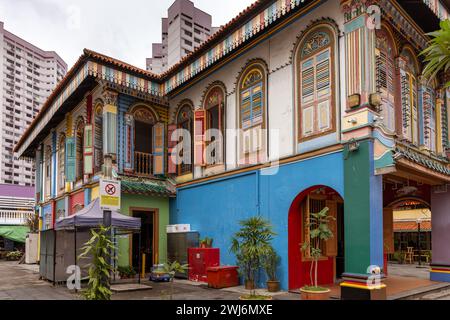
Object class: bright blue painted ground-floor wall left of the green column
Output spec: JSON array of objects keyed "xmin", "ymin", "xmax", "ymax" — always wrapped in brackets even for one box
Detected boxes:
[{"xmin": 170, "ymin": 152, "xmax": 344, "ymax": 290}]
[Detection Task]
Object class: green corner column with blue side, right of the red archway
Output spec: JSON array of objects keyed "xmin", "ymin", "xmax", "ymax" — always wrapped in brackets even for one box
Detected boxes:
[{"xmin": 344, "ymin": 139, "xmax": 383, "ymax": 275}]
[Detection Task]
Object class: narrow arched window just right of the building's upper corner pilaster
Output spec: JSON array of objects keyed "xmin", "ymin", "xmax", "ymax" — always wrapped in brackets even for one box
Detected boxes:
[{"xmin": 375, "ymin": 29, "xmax": 396, "ymax": 131}]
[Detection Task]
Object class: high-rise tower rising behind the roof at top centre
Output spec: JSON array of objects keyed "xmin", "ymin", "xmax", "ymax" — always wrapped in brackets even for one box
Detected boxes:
[{"xmin": 146, "ymin": 0, "xmax": 217, "ymax": 73}]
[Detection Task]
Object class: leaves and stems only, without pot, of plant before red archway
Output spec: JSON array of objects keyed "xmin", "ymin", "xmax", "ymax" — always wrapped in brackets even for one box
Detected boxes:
[{"xmin": 301, "ymin": 207, "xmax": 335, "ymax": 289}]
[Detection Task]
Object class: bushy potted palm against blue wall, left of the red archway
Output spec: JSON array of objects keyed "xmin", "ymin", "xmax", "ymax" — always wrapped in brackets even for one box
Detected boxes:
[{"xmin": 231, "ymin": 217, "xmax": 275, "ymax": 300}]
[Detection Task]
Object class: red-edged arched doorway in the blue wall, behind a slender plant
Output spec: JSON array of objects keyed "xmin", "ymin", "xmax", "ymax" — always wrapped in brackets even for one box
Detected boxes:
[{"xmin": 288, "ymin": 186, "xmax": 344, "ymax": 290}]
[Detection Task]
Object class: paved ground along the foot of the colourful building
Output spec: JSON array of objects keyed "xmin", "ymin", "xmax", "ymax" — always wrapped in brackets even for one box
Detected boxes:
[{"xmin": 0, "ymin": 261, "xmax": 450, "ymax": 300}]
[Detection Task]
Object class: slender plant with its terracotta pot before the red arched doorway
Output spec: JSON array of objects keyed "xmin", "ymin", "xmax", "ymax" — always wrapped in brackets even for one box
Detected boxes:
[{"xmin": 300, "ymin": 207, "xmax": 335, "ymax": 300}]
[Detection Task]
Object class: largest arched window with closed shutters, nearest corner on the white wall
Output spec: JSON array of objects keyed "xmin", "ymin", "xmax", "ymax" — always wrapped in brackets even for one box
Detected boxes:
[{"xmin": 296, "ymin": 26, "xmax": 335, "ymax": 141}]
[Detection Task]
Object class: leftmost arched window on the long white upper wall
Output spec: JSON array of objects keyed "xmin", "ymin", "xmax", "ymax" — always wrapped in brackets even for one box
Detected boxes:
[{"xmin": 177, "ymin": 103, "xmax": 194, "ymax": 176}]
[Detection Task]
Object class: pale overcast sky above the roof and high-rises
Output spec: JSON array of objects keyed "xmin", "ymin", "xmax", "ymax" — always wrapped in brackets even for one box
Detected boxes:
[{"xmin": 0, "ymin": 0, "xmax": 254, "ymax": 68}]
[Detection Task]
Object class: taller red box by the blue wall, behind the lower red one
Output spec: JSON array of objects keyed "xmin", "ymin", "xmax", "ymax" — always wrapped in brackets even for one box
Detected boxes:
[{"xmin": 188, "ymin": 248, "xmax": 220, "ymax": 282}]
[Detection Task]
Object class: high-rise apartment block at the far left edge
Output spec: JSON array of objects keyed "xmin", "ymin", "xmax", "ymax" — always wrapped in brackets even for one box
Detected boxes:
[{"xmin": 0, "ymin": 22, "xmax": 67, "ymax": 186}]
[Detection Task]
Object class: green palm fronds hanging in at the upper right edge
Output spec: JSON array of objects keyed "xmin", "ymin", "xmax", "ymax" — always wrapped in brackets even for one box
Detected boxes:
[{"xmin": 420, "ymin": 19, "xmax": 450, "ymax": 87}]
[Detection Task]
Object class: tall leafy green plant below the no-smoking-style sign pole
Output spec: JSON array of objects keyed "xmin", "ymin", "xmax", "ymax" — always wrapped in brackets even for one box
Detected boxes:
[{"xmin": 78, "ymin": 226, "xmax": 115, "ymax": 300}]
